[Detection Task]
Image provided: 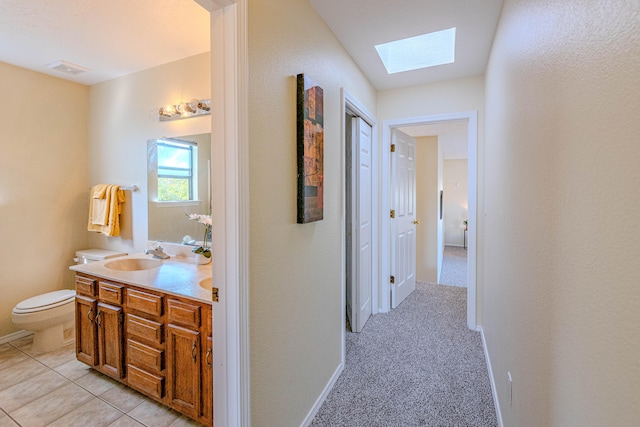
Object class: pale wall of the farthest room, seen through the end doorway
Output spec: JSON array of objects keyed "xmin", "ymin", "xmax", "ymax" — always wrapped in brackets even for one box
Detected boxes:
[{"xmin": 444, "ymin": 159, "xmax": 469, "ymax": 246}]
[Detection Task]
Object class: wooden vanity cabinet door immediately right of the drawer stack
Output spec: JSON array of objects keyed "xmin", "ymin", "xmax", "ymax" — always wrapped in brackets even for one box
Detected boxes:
[{"xmin": 167, "ymin": 324, "xmax": 201, "ymax": 418}]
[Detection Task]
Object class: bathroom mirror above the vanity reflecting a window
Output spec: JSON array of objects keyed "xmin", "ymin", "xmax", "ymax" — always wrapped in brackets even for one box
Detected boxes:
[{"xmin": 147, "ymin": 133, "xmax": 211, "ymax": 243}]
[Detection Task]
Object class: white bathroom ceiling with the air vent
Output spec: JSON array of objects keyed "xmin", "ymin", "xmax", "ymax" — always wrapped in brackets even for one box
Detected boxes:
[{"xmin": 0, "ymin": 0, "xmax": 210, "ymax": 85}]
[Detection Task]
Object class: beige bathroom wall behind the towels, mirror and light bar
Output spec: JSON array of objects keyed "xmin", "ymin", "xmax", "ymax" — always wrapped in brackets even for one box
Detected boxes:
[{"xmin": 85, "ymin": 52, "xmax": 211, "ymax": 253}]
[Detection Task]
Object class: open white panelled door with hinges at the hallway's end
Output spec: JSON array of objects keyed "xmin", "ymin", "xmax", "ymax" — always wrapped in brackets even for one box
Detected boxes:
[{"xmin": 391, "ymin": 129, "xmax": 416, "ymax": 308}]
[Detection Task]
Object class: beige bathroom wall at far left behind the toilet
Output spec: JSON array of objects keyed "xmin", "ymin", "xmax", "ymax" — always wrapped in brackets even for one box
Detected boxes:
[{"xmin": 0, "ymin": 63, "xmax": 89, "ymax": 337}]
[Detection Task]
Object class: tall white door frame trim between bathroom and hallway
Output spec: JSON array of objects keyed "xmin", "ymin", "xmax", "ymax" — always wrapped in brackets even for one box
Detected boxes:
[{"xmin": 209, "ymin": 0, "xmax": 251, "ymax": 427}]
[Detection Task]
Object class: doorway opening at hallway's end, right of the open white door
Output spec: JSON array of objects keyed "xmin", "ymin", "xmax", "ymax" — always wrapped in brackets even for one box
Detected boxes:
[{"xmin": 397, "ymin": 120, "xmax": 469, "ymax": 287}]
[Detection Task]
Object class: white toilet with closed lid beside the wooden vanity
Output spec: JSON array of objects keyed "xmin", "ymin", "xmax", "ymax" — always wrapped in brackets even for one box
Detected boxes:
[{"xmin": 11, "ymin": 249, "xmax": 126, "ymax": 353}]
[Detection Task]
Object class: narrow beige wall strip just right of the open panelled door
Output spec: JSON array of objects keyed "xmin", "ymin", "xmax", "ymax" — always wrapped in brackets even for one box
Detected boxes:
[{"xmin": 416, "ymin": 136, "xmax": 440, "ymax": 282}]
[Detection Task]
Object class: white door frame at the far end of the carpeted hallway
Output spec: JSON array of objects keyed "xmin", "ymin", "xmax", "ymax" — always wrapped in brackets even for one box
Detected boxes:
[{"xmin": 378, "ymin": 110, "xmax": 478, "ymax": 330}]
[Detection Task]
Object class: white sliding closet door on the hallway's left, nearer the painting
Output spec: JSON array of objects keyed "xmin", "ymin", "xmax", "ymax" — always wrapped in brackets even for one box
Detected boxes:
[{"xmin": 347, "ymin": 117, "xmax": 373, "ymax": 332}]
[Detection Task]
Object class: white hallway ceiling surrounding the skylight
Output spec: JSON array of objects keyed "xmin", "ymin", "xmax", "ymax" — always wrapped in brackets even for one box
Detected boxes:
[{"xmin": 309, "ymin": 0, "xmax": 503, "ymax": 90}]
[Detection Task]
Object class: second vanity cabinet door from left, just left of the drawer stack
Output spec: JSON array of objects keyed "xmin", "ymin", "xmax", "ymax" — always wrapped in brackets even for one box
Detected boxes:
[{"xmin": 96, "ymin": 303, "xmax": 124, "ymax": 379}]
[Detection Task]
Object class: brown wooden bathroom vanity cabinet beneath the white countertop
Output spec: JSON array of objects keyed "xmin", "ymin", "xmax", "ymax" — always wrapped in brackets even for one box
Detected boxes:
[{"xmin": 76, "ymin": 273, "xmax": 213, "ymax": 426}]
